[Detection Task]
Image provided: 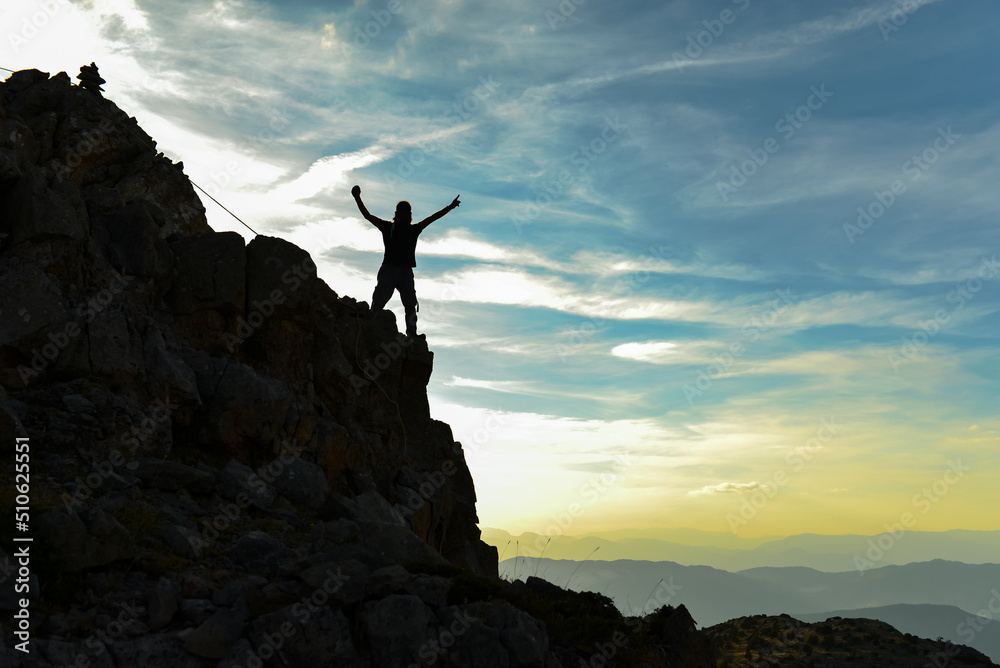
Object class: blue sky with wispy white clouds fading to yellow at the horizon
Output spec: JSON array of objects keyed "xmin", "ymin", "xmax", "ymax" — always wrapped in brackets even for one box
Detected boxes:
[{"xmin": 0, "ymin": 0, "xmax": 1000, "ymax": 537}]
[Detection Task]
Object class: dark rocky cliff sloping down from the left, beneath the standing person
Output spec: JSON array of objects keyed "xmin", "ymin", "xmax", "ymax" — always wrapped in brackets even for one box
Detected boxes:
[{"xmin": 0, "ymin": 70, "xmax": 713, "ymax": 668}]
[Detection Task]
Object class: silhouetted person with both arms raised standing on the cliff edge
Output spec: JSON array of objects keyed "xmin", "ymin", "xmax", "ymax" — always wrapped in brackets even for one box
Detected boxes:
[{"xmin": 351, "ymin": 186, "xmax": 461, "ymax": 336}]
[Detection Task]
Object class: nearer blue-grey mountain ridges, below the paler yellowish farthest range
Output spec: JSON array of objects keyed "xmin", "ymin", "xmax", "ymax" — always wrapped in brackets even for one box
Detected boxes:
[{"xmin": 500, "ymin": 557, "xmax": 1000, "ymax": 659}]
